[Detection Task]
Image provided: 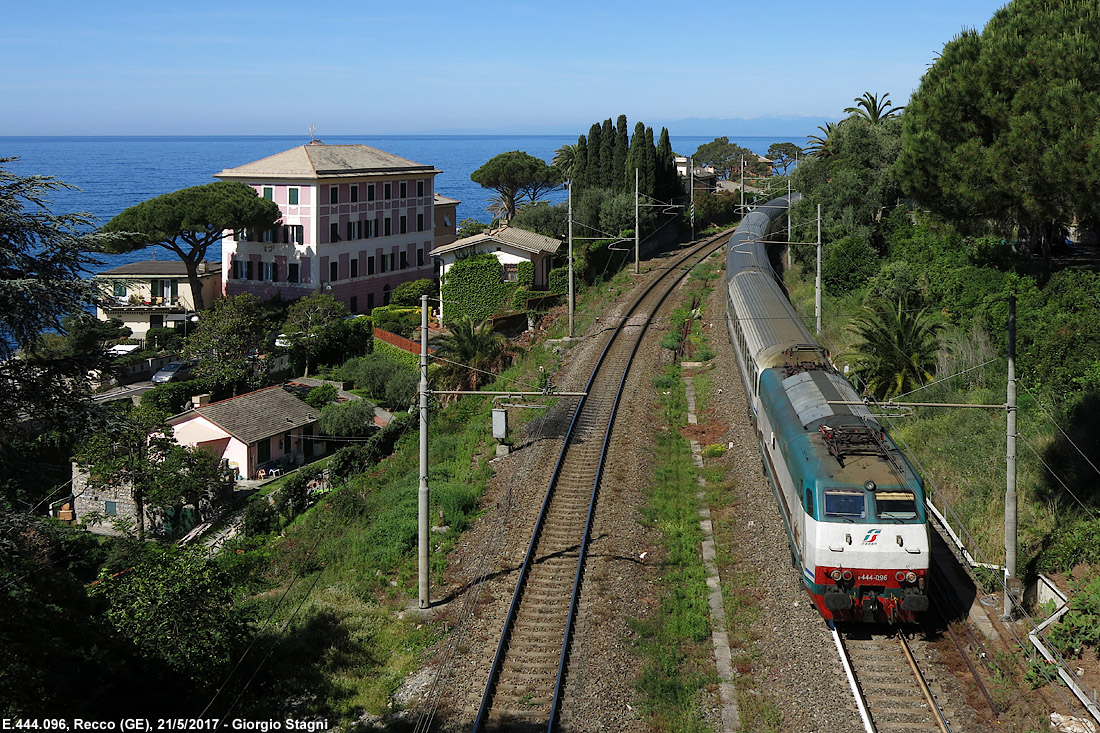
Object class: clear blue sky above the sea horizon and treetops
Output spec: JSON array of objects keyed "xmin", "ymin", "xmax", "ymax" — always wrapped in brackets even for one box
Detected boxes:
[{"xmin": 0, "ymin": 0, "xmax": 1003, "ymax": 136}]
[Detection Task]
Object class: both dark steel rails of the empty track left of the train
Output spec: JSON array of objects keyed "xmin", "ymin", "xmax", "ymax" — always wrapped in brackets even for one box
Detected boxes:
[{"xmin": 472, "ymin": 233, "xmax": 729, "ymax": 733}]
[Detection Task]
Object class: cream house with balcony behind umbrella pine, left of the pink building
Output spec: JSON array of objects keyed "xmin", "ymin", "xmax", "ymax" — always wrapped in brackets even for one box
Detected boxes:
[{"xmin": 96, "ymin": 260, "xmax": 221, "ymax": 339}]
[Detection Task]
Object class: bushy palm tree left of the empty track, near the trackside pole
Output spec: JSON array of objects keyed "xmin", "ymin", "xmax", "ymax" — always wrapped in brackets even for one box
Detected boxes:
[{"xmin": 435, "ymin": 316, "xmax": 516, "ymax": 390}]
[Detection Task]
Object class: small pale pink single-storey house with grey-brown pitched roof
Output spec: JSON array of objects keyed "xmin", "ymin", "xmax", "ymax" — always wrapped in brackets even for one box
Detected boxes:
[{"xmin": 168, "ymin": 386, "xmax": 323, "ymax": 479}]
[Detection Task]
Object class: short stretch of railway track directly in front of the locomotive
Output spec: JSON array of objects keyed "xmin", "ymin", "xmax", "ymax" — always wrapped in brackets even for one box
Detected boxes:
[{"xmin": 833, "ymin": 625, "xmax": 953, "ymax": 733}]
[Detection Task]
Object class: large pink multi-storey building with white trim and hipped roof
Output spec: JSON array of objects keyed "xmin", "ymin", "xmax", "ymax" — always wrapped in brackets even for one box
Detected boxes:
[{"xmin": 216, "ymin": 140, "xmax": 440, "ymax": 313}]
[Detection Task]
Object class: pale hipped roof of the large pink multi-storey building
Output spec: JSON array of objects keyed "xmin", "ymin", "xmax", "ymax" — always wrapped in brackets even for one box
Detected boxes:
[{"xmin": 215, "ymin": 144, "xmax": 441, "ymax": 179}]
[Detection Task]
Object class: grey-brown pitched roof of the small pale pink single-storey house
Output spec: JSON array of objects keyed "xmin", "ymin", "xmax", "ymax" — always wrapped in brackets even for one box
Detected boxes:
[{"xmin": 168, "ymin": 386, "xmax": 318, "ymax": 445}]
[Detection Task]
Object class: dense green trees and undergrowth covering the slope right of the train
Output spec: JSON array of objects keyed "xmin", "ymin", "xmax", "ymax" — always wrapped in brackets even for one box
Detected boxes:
[{"xmin": 793, "ymin": 0, "xmax": 1100, "ymax": 585}]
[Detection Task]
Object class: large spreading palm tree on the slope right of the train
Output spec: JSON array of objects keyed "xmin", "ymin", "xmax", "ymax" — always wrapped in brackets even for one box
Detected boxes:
[{"xmin": 853, "ymin": 298, "xmax": 944, "ymax": 400}]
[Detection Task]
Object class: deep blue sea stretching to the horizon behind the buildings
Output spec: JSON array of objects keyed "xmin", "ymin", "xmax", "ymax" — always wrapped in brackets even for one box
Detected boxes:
[{"xmin": 0, "ymin": 131, "xmax": 807, "ymax": 273}]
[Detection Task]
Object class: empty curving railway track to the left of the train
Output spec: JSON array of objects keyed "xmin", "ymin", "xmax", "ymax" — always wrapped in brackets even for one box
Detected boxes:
[{"xmin": 473, "ymin": 233, "xmax": 728, "ymax": 731}]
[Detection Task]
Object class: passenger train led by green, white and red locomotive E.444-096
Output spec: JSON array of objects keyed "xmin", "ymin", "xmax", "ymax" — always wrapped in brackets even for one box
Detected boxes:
[{"xmin": 726, "ymin": 193, "xmax": 931, "ymax": 624}]
